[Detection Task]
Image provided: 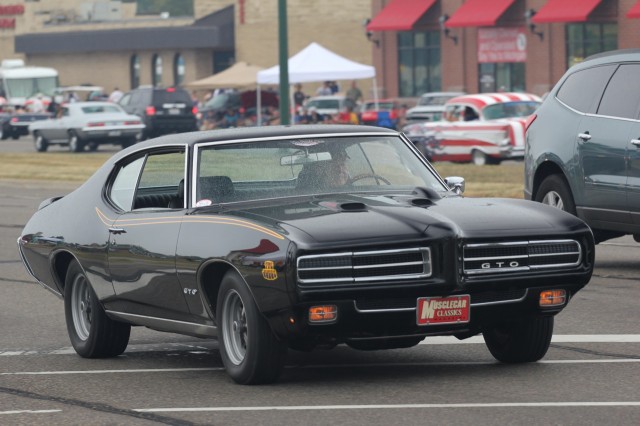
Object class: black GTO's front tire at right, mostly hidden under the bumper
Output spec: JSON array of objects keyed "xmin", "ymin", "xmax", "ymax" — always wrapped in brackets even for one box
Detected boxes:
[{"xmin": 482, "ymin": 315, "xmax": 553, "ymax": 363}]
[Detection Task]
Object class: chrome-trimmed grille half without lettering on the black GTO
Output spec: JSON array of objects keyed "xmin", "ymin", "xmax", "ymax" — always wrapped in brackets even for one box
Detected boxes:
[{"xmin": 297, "ymin": 247, "xmax": 431, "ymax": 286}]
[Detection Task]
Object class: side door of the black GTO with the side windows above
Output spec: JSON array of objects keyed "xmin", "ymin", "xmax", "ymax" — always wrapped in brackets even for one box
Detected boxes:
[{"xmin": 108, "ymin": 148, "xmax": 189, "ymax": 320}]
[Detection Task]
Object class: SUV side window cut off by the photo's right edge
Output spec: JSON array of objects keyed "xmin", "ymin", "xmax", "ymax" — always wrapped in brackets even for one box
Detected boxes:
[{"xmin": 598, "ymin": 64, "xmax": 640, "ymax": 118}]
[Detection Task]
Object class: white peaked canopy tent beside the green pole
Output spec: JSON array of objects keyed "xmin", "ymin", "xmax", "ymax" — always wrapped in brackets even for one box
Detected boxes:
[{"xmin": 257, "ymin": 43, "xmax": 378, "ymax": 122}]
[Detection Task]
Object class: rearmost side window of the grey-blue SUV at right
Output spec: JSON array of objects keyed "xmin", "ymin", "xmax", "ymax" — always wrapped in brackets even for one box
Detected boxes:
[{"xmin": 556, "ymin": 65, "xmax": 616, "ymax": 112}]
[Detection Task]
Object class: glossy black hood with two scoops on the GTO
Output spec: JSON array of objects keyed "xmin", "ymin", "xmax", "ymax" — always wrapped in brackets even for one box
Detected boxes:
[{"xmin": 211, "ymin": 194, "xmax": 585, "ymax": 245}]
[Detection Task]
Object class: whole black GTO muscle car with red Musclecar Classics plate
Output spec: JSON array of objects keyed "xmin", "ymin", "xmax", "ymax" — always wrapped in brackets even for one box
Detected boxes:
[{"xmin": 18, "ymin": 126, "xmax": 594, "ymax": 384}]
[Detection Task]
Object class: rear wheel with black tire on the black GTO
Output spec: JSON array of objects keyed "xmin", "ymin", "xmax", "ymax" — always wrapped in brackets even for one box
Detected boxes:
[{"xmin": 64, "ymin": 261, "xmax": 131, "ymax": 358}]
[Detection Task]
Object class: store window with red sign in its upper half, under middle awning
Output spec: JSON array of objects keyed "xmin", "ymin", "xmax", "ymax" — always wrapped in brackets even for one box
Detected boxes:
[{"xmin": 478, "ymin": 27, "xmax": 527, "ymax": 93}]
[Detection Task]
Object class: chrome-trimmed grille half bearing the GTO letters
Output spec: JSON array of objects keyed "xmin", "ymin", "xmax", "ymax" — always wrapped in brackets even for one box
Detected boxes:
[{"xmin": 463, "ymin": 240, "xmax": 582, "ymax": 275}]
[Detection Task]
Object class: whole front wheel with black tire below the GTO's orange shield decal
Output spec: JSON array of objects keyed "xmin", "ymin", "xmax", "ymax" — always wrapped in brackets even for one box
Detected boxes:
[{"xmin": 216, "ymin": 272, "xmax": 287, "ymax": 385}]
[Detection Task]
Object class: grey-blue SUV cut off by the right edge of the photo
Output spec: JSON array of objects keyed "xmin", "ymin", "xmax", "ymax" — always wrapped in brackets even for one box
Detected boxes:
[{"xmin": 525, "ymin": 49, "xmax": 640, "ymax": 241}]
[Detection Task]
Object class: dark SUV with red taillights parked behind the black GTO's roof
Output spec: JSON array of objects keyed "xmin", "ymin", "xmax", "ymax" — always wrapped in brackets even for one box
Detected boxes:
[{"xmin": 118, "ymin": 87, "xmax": 198, "ymax": 139}]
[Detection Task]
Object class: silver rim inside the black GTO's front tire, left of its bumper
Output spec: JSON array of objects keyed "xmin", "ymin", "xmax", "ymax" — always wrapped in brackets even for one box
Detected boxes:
[{"xmin": 222, "ymin": 290, "xmax": 248, "ymax": 365}]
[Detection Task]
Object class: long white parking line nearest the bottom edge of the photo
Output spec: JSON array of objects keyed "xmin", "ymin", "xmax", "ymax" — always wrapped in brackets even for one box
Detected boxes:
[{"xmin": 133, "ymin": 401, "xmax": 640, "ymax": 413}]
